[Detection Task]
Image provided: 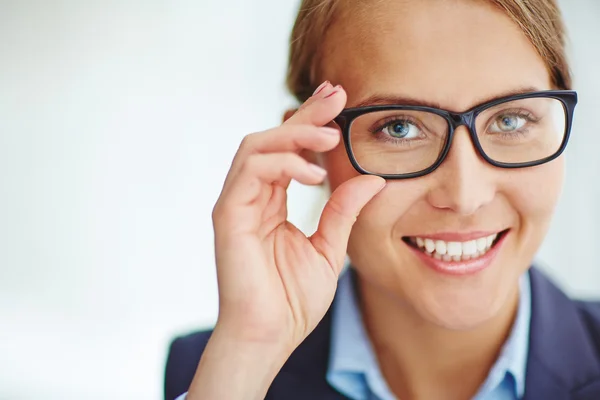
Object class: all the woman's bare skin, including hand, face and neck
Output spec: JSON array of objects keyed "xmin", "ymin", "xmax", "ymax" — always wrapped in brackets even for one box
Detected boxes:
[{"xmin": 188, "ymin": 0, "xmax": 564, "ymax": 399}]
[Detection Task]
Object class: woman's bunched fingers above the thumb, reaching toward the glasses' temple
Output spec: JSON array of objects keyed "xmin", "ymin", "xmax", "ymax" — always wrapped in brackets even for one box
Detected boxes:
[{"xmin": 213, "ymin": 82, "xmax": 346, "ymax": 234}]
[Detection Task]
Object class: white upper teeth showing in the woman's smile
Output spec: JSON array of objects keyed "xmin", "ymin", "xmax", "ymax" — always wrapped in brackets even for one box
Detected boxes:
[{"xmin": 410, "ymin": 233, "xmax": 498, "ymax": 262}]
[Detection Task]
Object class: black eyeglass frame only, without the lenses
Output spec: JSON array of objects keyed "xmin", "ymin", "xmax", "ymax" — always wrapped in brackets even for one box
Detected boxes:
[{"xmin": 334, "ymin": 90, "xmax": 578, "ymax": 179}]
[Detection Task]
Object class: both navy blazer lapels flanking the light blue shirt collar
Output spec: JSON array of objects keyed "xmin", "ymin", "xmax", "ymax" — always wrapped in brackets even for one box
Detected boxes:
[{"xmin": 266, "ymin": 268, "xmax": 600, "ymax": 400}]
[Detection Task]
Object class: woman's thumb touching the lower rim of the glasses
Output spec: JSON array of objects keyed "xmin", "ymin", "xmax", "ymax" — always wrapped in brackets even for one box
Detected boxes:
[{"xmin": 310, "ymin": 175, "xmax": 385, "ymax": 274}]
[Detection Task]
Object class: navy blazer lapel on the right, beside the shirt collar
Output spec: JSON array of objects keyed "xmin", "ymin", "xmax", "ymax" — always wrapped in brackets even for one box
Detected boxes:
[{"xmin": 524, "ymin": 268, "xmax": 600, "ymax": 400}]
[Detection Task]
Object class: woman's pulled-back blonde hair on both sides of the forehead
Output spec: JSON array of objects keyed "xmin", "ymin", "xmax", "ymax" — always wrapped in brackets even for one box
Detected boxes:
[{"xmin": 287, "ymin": 0, "xmax": 572, "ymax": 102}]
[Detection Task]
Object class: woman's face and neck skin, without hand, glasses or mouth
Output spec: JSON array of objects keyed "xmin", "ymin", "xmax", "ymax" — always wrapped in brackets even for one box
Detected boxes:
[{"xmin": 322, "ymin": 1, "xmax": 564, "ymax": 399}]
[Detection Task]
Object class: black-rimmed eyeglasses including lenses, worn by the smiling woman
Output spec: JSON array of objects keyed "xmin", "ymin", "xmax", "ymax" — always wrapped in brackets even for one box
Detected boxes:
[{"xmin": 335, "ymin": 90, "xmax": 577, "ymax": 179}]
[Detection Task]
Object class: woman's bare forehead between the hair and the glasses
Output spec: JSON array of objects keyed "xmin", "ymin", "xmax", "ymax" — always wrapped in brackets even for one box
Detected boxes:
[{"xmin": 320, "ymin": 0, "xmax": 550, "ymax": 111}]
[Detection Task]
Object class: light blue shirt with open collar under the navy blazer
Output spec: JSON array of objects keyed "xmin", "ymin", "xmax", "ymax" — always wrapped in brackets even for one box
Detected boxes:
[{"xmin": 327, "ymin": 270, "xmax": 531, "ymax": 400}]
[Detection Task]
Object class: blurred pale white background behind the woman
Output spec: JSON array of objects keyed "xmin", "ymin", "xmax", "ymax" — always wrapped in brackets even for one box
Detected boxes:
[{"xmin": 0, "ymin": 0, "xmax": 600, "ymax": 400}]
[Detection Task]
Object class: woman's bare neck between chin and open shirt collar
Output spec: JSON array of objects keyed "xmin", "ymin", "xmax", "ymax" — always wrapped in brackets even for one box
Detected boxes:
[{"xmin": 357, "ymin": 272, "xmax": 519, "ymax": 399}]
